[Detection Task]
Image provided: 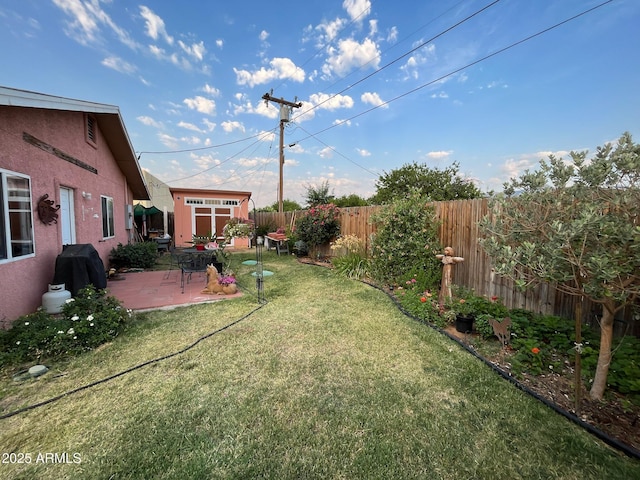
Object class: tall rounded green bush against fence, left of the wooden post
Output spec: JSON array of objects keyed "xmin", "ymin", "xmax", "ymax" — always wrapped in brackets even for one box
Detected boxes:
[{"xmin": 371, "ymin": 192, "xmax": 442, "ymax": 287}]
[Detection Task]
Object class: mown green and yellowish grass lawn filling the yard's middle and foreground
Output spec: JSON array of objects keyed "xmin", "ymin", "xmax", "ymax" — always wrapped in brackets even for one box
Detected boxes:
[{"xmin": 0, "ymin": 252, "xmax": 640, "ymax": 480}]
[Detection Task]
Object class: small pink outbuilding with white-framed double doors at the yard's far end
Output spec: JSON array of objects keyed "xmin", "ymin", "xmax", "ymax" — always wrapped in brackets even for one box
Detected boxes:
[{"xmin": 169, "ymin": 187, "xmax": 251, "ymax": 247}]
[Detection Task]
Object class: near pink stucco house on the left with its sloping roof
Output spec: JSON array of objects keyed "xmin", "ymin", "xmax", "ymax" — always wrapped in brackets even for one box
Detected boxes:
[{"xmin": 0, "ymin": 87, "xmax": 149, "ymax": 327}]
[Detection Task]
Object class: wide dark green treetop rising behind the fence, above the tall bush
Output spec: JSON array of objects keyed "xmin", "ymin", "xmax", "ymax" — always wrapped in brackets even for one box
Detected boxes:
[{"xmin": 370, "ymin": 162, "xmax": 482, "ymax": 205}]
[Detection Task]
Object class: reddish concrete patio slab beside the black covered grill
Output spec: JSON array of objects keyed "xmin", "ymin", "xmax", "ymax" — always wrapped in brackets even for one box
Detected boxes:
[{"xmin": 107, "ymin": 269, "xmax": 242, "ymax": 311}]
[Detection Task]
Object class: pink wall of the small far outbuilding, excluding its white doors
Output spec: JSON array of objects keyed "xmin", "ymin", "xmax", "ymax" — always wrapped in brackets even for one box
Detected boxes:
[{"xmin": 171, "ymin": 188, "xmax": 251, "ymax": 247}]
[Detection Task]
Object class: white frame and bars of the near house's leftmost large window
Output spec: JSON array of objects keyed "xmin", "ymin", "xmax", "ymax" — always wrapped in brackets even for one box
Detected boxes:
[{"xmin": 0, "ymin": 168, "xmax": 36, "ymax": 263}]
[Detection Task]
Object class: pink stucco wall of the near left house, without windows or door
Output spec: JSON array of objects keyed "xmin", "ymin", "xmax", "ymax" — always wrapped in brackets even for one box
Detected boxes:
[{"xmin": 0, "ymin": 106, "xmax": 132, "ymax": 327}]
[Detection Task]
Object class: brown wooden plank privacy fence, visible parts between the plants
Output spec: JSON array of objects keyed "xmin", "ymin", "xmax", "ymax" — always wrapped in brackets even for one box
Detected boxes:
[{"xmin": 254, "ymin": 198, "xmax": 640, "ymax": 336}]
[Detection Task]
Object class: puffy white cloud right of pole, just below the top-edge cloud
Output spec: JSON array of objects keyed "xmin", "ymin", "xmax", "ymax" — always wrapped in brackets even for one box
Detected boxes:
[{"xmin": 322, "ymin": 38, "xmax": 380, "ymax": 77}]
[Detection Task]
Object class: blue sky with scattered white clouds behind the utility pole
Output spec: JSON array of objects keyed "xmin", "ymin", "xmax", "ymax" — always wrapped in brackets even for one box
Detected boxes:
[{"xmin": 0, "ymin": 0, "xmax": 640, "ymax": 207}]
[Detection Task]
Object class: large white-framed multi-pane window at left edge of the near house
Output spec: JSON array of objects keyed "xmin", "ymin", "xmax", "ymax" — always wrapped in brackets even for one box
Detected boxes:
[{"xmin": 0, "ymin": 169, "xmax": 35, "ymax": 261}]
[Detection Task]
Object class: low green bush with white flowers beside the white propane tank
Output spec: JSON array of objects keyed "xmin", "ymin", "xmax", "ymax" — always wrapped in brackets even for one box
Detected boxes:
[{"xmin": 0, "ymin": 285, "xmax": 132, "ymax": 367}]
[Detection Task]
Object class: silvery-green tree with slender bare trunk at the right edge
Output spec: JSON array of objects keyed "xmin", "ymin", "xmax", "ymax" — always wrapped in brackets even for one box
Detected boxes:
[{"xmin": 481, "ymin": 133, "xmax": 640, "ymax": 400}]
